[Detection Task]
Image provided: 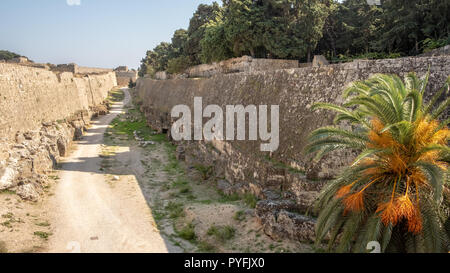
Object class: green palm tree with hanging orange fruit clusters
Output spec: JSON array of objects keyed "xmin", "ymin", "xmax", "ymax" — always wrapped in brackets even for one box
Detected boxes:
[{"xmin": 306, "ymin": 73, "xmax": 450, "ymax": 252}]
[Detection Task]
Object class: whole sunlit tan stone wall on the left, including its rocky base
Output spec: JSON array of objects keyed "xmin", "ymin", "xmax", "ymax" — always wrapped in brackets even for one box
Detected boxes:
[{"xmin": 0, "ymin": 63, "xmax": 117, "ymax": 200}]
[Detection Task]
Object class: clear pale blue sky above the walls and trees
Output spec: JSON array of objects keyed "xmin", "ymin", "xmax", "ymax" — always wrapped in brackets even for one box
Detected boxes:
[{"xmin": 0, "ymin": 0, "xmax": 216, "ymax": 68}]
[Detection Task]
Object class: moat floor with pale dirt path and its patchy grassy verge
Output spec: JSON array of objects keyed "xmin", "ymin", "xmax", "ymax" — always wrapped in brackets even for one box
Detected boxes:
[{"xmin": 43, "ymin": 90, "xmax": 312, "ymax": 253}]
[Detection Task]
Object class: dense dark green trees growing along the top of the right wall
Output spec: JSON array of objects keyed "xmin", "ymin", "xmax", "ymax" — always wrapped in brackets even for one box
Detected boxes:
[{"xmin": 140, "ymin": 0, "xmax": 450, "ymax": 76}]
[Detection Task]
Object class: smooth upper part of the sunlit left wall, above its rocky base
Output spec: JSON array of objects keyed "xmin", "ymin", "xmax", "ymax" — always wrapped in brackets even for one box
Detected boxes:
[{"xmin": 0, "ymin": 64, "xmax": 117, "ymax": 137}]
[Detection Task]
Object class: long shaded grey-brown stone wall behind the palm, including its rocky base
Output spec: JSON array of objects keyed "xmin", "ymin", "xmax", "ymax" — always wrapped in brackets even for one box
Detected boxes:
[{"xmin": 137, "ymin": 56, "xmax": 450, "ymax": 240}]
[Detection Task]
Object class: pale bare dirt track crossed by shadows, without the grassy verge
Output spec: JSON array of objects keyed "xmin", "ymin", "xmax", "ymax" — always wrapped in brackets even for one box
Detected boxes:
[{"xmin": 48, "ymin": 90, "xmax": 170, "ymax": 253}]
